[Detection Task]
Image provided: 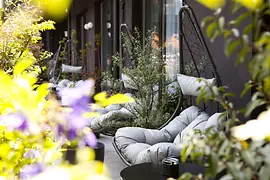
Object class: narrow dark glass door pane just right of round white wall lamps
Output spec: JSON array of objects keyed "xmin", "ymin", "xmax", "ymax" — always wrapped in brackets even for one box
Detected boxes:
[{"xmin": 101, "ymin": 0, "xmax": 112, "ymax": 70}]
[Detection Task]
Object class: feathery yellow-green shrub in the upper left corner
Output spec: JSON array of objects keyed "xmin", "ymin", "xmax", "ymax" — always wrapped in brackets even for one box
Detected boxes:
[{"xmin": 0, "ymin": 0, "xmax": 54, "ymax": 73}]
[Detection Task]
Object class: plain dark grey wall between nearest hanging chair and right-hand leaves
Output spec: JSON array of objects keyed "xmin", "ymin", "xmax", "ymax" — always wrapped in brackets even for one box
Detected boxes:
[{"xmin": 187, "ymin": 0, "xmax": 251, "ymax": 111}]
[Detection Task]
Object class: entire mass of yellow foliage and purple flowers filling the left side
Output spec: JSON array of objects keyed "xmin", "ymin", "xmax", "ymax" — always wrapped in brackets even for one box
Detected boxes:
[{"xmin": 0, "ymin": 0, "xmax": 133, "ymax": 180}]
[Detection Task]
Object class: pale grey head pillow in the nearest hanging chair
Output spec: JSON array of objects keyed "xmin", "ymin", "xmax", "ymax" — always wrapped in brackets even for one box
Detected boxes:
[{"xmin": 177, "ymin": 74, "xmax": 216, "ymax": 96}]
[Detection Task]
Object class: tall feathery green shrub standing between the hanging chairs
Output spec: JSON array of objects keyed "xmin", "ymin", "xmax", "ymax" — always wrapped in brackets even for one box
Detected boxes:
[{"xmin": 102, "ymin": 29, "xmax": 179, "ymax": 128}]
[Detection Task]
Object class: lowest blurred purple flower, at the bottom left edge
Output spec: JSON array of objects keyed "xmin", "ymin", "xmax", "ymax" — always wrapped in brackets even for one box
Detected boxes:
[{"xmin": 20, "ymin": 163, "xmax": 43, "ymax": 179}]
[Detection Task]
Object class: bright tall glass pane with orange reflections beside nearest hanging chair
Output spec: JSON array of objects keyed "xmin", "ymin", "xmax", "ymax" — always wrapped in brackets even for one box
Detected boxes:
[{"xmin": 164, "ymin": 0, "xmax": 182, "ymax": 80}]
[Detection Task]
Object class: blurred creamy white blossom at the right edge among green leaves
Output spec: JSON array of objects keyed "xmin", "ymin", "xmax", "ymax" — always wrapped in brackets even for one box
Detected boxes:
[{"xmin": 232, "ymin": 109, "xmax": 270, "ymax": 141}]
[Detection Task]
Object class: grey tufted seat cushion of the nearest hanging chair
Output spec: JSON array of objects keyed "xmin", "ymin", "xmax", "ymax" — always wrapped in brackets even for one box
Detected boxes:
[{"xmin": 115, "ymin": 106, "xmax": 224, "ymax": 164}]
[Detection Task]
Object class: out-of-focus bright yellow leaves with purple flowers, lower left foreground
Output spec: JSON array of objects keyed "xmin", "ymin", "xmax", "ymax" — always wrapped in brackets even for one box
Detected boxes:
[{"xmin": 0, "ymin": 56, "xmax": 134, "ymax": 179}]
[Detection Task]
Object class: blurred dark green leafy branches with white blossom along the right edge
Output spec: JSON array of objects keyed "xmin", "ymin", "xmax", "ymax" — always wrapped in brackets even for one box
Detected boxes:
[{"xmin": 181, "ymin": 0, "xmax": 270, "ymax": 180}]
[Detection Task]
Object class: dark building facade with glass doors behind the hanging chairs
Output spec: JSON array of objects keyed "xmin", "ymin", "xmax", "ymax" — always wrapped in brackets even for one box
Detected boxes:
[{"xmin": 47, "ymin": 0, "xmax": 249, "ymax": 108}]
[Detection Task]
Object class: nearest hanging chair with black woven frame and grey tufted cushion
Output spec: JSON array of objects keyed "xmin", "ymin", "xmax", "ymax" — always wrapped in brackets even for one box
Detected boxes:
[{"xmin": 112, "ymin": 3, "xmax": 224, "ymax": 166}]
